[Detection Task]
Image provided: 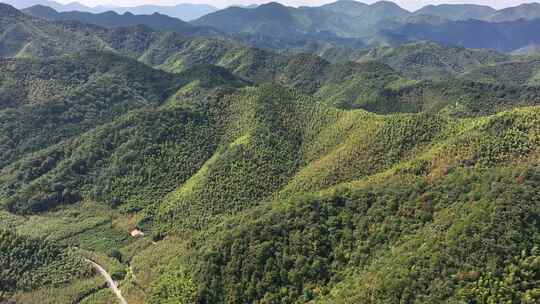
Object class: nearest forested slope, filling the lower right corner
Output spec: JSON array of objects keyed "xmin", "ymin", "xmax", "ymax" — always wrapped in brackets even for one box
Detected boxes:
[{"xmin": 160, "ymin": 108, "xmax": 540, "ymax": 303}]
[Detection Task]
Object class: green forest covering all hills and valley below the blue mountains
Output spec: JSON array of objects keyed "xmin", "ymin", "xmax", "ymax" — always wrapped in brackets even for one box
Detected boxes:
[{"xmin": 0, "ymin": 2, "xmax": 540, "ymax": 304}]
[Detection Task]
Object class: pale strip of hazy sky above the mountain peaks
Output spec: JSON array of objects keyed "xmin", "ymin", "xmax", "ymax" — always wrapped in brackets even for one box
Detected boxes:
[{"xmin": 57, "ymin": 0, "xmax": 534, "ymax": 10}]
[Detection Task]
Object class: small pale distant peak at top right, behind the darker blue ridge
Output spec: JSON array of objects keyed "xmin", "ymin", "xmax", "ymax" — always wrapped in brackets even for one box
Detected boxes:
[{"xmin": 414, "ymin": 4, "xmax": 497, "ymax": 21}]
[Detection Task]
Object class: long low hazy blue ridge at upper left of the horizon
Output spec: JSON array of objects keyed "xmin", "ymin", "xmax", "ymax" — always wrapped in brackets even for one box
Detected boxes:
[{"xmin": 23, "ymin": 5, "xmax": 219, "ymax": 36}]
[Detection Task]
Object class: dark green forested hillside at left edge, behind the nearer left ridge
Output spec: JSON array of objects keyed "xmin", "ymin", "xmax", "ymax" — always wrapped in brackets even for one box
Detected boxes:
[{"xmin": 0, "ymin": 53, "xmax": 189, "ymax": 168}]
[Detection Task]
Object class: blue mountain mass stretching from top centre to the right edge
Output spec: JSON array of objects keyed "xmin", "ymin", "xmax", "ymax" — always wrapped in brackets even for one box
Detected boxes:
[{"xmin": 193, "ymin": 1, "xmax": 538, "ymax": 52}]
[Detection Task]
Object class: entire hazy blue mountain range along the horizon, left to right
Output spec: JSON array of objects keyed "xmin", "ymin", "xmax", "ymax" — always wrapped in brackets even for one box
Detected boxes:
[{"xmin": 17, "ymin": 0, "xmax": 540, "ymax": 53}]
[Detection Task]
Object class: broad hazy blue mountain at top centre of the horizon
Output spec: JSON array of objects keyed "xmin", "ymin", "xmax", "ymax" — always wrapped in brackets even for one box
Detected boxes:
[{"xmin": 192, "ymin": 1, "xmax": 409, "ymax": 38}]
